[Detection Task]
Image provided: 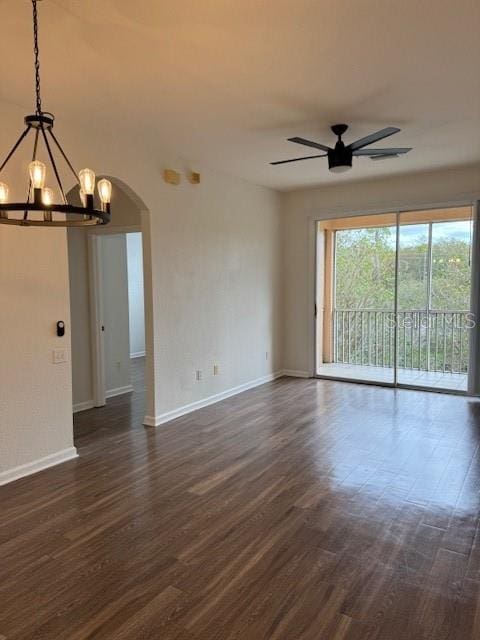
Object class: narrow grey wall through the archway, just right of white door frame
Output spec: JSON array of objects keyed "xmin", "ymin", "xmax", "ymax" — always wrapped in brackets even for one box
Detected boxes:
[{"xmin": 100, "ymin": 233, "xmax": 130, "ymax": 397}]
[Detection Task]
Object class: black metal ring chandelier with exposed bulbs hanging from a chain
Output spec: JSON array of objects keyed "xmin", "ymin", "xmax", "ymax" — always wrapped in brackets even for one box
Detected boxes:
[{"xmin": 0, "ymin": 0, "xmax": 112, "ymax": 227}]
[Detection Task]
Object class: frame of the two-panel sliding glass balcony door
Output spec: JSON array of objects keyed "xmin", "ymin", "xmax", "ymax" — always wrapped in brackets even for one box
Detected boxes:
[{"xmin": 309, "ymin": 201, "xmax": 480, "ymax": 396}]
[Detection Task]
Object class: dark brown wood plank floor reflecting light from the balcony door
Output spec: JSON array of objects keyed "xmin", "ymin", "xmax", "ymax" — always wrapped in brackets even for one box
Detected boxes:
[{"xmin": 0, "ymin": 364, "xmax": 480, "ymax": 640}]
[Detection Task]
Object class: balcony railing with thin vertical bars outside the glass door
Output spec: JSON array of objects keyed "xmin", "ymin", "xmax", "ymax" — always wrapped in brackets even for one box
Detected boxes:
[{"xmin": 334, "ymin": 309, "xmax": 473, "ymax": 373}]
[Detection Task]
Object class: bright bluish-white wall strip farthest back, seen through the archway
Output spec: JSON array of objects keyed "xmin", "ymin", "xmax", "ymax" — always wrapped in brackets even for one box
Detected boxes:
[{"xmin": 127, "ymin": 233, "xmax": 145, "ymax": 358}]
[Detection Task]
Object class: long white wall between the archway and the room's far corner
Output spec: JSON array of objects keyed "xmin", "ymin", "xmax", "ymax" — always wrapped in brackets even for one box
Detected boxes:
[{"xmin": 151, "ymin": 171, "xmax": 282, "ymax": 419}]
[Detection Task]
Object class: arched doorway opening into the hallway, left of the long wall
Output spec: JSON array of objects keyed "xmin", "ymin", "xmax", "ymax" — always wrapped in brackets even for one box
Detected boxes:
[{"xmin": 67, "ymin": 179, "xmax": 154, "ymax": 424}]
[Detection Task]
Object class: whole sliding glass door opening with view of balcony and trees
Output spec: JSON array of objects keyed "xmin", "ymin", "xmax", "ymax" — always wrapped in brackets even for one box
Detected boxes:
[{"xmin": 316, "ymin": 206, "xmax": 477, "ymax": 393}]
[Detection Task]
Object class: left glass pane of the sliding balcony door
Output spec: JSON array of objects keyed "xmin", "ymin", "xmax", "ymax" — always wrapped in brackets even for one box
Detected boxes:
[{"xmin": 318, "ymin": 214, "xmax": 396, "ymax": 383}]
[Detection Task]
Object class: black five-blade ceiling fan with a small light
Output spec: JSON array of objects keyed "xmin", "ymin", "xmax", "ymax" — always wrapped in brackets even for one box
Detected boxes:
[{"xmin": 270, "ymin": 124, "xmax": 411, "ymax": 173}]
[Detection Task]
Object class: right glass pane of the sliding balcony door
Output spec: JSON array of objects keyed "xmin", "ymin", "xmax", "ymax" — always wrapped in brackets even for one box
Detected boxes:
[{"xmin": 397, "ymin": 210, "xmax": 470, "ymax": 391}]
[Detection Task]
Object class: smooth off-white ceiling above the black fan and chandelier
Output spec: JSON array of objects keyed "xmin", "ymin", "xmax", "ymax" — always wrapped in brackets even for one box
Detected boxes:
[{"xmin": 0, "ymin": 0, "xmax": 480, "ymax": 190}]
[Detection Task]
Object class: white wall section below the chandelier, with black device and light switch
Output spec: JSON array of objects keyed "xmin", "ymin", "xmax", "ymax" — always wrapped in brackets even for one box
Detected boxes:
[{"xmin": 0, "ymin": 226, "xmax": 75, "ymax": 484}]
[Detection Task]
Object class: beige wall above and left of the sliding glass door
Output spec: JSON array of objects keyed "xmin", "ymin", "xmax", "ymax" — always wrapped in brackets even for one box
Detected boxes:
[{"xmin": 282, "ymin": 166, "xmax": 480, "ymax": 376}]
